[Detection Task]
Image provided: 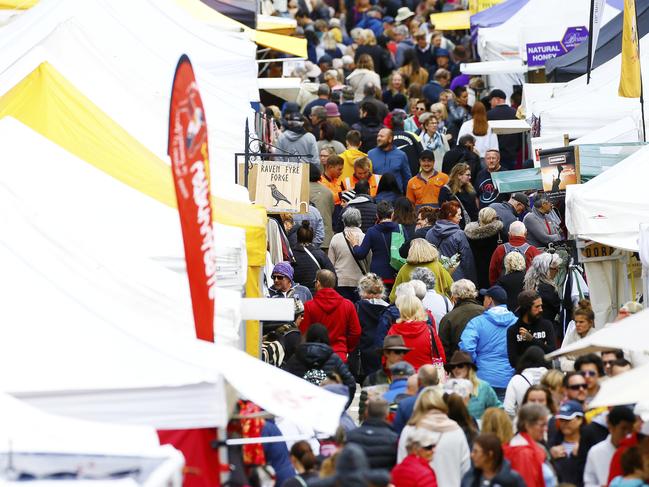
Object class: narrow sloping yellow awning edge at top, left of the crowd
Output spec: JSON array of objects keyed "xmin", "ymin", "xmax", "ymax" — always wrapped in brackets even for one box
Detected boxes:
[{"xmin": 172, "ymin": 0, "xmax": 307, "ymax": 58}]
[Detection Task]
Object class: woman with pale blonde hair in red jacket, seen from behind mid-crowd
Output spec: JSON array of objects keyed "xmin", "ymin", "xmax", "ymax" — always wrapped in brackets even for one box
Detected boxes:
[{"xmin": 388, "ymin": 295, "xmax": 441, "ymax": 370}]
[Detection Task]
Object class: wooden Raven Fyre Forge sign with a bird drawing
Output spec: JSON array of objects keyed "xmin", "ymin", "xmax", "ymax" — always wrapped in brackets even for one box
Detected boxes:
[{"xmin": 249, "ymin": 161, "xmax": 309, "ymax": 213}]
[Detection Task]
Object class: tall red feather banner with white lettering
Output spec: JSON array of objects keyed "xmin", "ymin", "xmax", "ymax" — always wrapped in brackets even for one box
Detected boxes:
[{"xmin": 168, "ymin": 55, "xmax": 216, "ymax": 341}]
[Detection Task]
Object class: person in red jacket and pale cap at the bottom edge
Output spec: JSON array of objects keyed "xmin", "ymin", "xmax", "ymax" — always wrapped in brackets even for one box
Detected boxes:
[{"xmin": 392, "ymin": 428, "xmax": 439, "ymax": 487}]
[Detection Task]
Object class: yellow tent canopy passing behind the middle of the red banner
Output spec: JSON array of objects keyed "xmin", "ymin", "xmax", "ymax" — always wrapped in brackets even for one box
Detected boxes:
[{"xmin": 0, "ymin": 63, "xmax": 266, "ymax": 267}]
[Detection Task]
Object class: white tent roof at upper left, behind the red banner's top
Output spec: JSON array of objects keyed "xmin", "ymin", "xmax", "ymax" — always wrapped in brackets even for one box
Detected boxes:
[{"xmin": 0, "ymin": 0, "xmax": 258, "ymax": 189}]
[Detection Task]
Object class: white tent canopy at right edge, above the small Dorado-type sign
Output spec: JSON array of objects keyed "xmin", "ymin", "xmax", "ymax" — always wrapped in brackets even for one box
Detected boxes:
[{"xmin": 566, "ymin": 142, "xmax": 649, "ymax": 251}]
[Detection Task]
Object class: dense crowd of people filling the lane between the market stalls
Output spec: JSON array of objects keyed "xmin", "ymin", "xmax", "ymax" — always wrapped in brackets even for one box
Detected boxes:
[{"xmin": 246, "ymin": 0, "xmax": 649, "ymax": 487}]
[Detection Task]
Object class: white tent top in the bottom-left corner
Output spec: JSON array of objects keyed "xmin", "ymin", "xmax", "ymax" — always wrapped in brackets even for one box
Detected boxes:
[{"xmin": 0, "ymin": 394, "xmax": 185, "ymax": 487}]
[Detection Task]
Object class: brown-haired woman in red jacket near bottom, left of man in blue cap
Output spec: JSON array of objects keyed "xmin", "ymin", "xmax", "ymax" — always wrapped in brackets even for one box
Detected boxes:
[{"xmin": 504, "ymin": 403, "xmax": 556, "ymax": 487}]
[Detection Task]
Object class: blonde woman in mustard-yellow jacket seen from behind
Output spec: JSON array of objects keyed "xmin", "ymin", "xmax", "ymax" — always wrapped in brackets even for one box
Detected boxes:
[{"xmin": 390, "ymin": 238, "xmax": 453, "ymax": 303}]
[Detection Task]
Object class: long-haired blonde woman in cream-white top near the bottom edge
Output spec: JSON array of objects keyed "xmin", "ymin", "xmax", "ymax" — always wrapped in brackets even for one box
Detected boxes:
[{"xmin": 397, "ymin": 386, "xmax": 471, "ymax": 486}]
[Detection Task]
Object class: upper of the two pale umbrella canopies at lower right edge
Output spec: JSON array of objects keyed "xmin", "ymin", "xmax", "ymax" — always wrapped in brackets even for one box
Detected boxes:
[{"xmin": 547, "ymin": 310, "xmax": 649, "ymax": 358}]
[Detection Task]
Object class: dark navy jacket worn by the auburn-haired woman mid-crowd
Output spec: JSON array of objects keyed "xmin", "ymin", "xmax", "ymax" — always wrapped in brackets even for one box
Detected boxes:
[{"xmin": 426, "ymin": 220, "xmax": 477, "ymax": 282}]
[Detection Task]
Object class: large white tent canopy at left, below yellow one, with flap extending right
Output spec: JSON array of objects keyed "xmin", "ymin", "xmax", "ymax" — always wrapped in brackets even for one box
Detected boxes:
[{"xmin": 0, "ymin": 118, "xmax": 345, "ymax": 432}]
